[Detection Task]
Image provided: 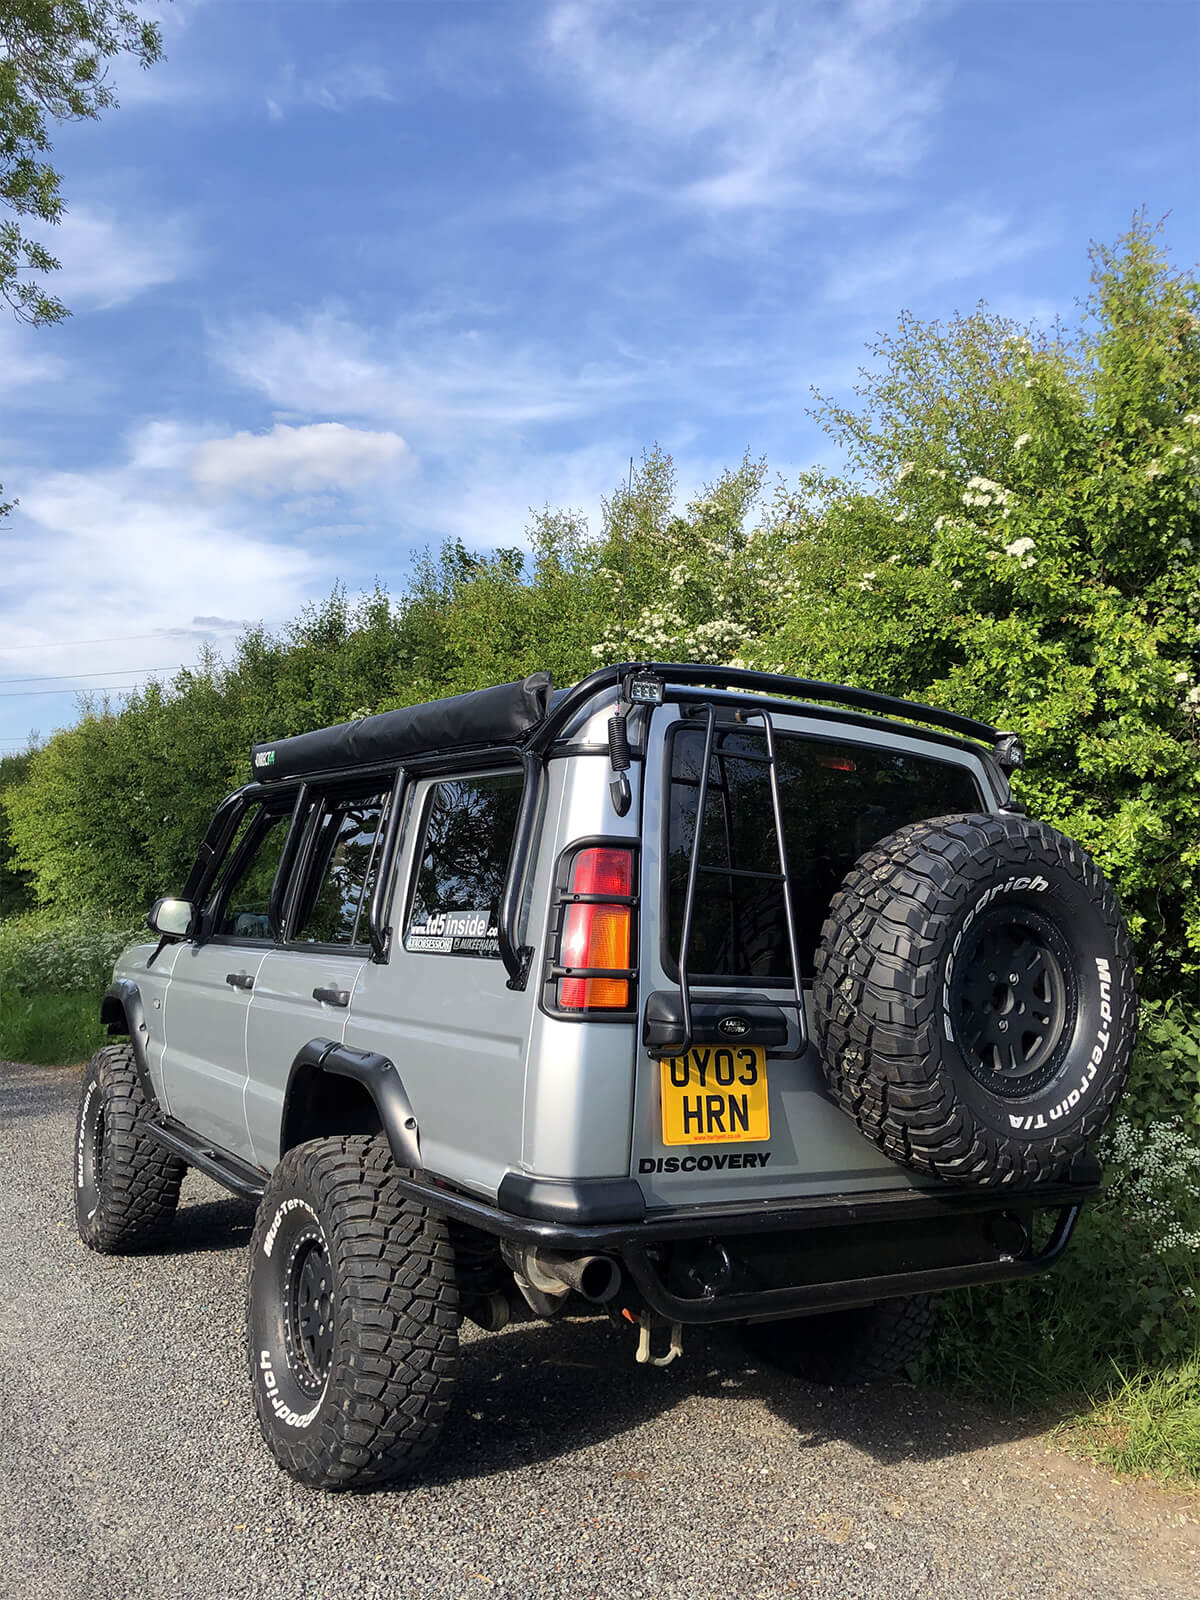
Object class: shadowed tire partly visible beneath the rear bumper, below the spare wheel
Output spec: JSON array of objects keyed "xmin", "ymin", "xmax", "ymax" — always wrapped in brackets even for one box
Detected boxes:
[{"xmin": 746, "ymin": 1294, "xmax": 938, "ymax": 1386}]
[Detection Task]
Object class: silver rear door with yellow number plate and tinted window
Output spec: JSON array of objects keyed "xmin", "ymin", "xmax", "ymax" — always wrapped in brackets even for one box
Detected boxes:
[{"xmin": 630, "ymin": 707, "xmax": 994, "ymax": 1206}]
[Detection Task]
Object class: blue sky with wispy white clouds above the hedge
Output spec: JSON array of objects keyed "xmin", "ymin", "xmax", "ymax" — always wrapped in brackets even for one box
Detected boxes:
[{"xmin": 0, "ymin": 0, "xmax": 1200, "ymax": 750}]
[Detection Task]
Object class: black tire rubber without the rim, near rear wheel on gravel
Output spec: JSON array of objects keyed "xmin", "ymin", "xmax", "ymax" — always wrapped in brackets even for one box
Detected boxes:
[{"xmin": 246, "ymin": 1134, "xmax": 459, "ymax": 1490}]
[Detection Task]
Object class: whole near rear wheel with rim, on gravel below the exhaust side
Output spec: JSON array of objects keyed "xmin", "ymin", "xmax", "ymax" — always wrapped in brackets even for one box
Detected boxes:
[{"xmin": 246, "ymin": 1136, "xmax": 459, "ymax": 1490}]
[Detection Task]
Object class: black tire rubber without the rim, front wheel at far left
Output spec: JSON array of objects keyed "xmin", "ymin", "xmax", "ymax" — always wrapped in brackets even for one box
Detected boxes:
[{"xmin": 72, "ymin": 1045, "xmax": 186, "ymax": 1256}]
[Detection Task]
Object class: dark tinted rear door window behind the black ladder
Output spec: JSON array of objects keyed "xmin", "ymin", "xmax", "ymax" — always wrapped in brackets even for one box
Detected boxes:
[{"xmin": 667, "ymin": 728, "xmax": 982, "ymax": 979}]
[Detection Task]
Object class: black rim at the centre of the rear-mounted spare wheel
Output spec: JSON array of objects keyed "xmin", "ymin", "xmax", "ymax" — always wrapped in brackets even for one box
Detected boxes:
[{"xmin": 950, "ymin": 906, "xmax": 1075, "ymax": 1099}]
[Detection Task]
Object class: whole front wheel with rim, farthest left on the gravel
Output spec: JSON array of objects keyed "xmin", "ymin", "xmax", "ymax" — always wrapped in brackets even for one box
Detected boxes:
[{"xmin": 75, "ymin": 1045, "xmax": 184, "ymax": 1256}]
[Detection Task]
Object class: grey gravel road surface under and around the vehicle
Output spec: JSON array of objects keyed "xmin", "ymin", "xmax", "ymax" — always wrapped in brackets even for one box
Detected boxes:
[{"xmin": 0, "ymin": 1064, "xmax": 1200, "ymax": 1600}]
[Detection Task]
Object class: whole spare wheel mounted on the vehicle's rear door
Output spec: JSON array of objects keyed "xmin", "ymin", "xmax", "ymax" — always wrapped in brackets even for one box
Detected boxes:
[{"xmin": 813, "ymin": 814, "xmax": 1136, "ymax": 1186}]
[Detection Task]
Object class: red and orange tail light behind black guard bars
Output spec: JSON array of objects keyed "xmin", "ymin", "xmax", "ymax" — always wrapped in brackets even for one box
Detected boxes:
[{"xmin": 557, "ymin": 845, "xmax": 634, "ymax": 1011}]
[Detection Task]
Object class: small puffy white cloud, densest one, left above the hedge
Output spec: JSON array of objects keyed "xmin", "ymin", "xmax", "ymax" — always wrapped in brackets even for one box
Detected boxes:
[{"xmin": 192, "ymin": 422, "xmax": 411, "ymax": 494}]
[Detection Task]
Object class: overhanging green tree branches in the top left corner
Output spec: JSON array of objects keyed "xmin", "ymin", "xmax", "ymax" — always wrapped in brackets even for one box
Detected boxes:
[{"xmin": 0, "ymin": 0, "xmax": 163, "ymax": 325}]
